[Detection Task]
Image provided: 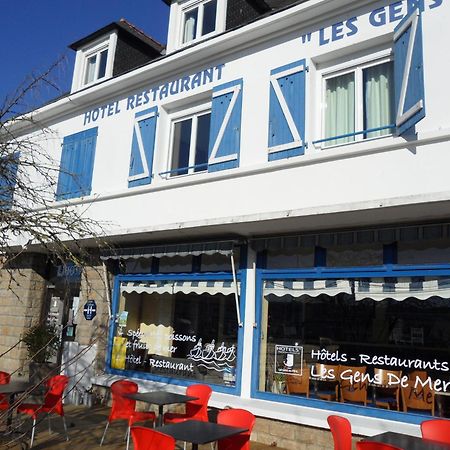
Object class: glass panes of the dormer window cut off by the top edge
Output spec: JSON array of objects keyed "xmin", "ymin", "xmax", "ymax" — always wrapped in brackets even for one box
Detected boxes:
[{"xmin": 182, "ymin": 0, "xmax": 217, "ymax": 44}]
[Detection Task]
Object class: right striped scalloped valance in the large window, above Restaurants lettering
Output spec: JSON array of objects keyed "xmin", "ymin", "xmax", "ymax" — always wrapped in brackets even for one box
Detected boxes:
[{"xmin": 355, "ymin": 278, "xmax": 450, "ymax": 302}]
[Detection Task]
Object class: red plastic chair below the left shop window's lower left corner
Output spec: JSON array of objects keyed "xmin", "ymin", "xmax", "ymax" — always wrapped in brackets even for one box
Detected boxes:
[{"xmin": 100, "ymin": 380, "xmax": 156, "ymax": 449}]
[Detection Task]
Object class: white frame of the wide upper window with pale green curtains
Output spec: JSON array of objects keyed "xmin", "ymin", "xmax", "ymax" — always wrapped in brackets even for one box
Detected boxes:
[{"xmin": 313, "ymin": 49, "xmax": 395, "ymax": 149}]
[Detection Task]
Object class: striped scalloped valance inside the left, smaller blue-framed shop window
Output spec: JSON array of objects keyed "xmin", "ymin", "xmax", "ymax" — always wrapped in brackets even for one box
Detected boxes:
[{"xmin": 120, "ymin": 280, "xmax": 240, "ymax": 295}]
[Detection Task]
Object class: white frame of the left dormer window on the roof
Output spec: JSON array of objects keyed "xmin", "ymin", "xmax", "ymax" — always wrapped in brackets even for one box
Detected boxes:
[{"xmin": 71, "ymin": 31, "xmax": 117, "ymax": 92}]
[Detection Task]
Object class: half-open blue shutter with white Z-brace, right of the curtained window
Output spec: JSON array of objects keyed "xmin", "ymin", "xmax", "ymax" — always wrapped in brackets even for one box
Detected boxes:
[{"xmin": 394, "ymin": 9, "xmax": 425, "ymax": 136}]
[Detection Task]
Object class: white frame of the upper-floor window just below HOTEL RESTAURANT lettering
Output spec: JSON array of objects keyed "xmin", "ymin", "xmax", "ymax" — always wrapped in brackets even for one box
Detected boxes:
[{"xmin": 166, "ymin": 102, "xmax": 212, "ymax": 179}]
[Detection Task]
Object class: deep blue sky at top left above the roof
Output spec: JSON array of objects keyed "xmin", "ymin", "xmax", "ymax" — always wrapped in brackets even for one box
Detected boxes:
[{"xmin": 0, "ymin": 0, "xmax": 169, "ymax": 109}]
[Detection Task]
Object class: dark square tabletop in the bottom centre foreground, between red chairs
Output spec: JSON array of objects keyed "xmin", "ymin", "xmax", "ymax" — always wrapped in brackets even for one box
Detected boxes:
[{"xmin": 156, "ymin": 420, "xmax": 248, "ymax": 450}]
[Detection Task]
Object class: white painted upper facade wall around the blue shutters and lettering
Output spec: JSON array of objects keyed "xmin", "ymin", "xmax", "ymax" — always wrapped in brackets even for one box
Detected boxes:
[{"xmin": 21, "ymin": 0, "xmax": 450, "ymax": 243}]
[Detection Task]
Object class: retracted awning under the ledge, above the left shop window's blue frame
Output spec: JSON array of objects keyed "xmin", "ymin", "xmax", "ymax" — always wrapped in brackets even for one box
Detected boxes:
[{"xmin": 100, "ymin": 240, "xmax": 237, "ymax": 260}]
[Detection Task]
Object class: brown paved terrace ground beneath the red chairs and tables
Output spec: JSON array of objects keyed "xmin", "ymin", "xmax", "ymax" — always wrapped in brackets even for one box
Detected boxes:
[{"xmin": 0, "ymin": 406, "xmax": 280, "ymax": 450}]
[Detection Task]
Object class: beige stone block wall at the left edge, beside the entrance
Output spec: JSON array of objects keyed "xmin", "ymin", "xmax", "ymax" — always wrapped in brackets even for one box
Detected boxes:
[{"xmin": 0, "ymin": 254, "xmax": 47, "ymax": 378}]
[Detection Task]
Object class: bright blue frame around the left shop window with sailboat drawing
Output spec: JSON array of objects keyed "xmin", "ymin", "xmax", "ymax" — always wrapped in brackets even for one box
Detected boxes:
[{"xmin": 106, "ymin": 270, "xmax": 247, "ymax": 395}]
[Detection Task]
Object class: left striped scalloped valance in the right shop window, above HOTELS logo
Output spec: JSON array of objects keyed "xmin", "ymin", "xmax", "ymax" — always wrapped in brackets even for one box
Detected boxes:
[{"xmin": 264, "ymin": 280, "xmax": 352, "ymax": 297}]
